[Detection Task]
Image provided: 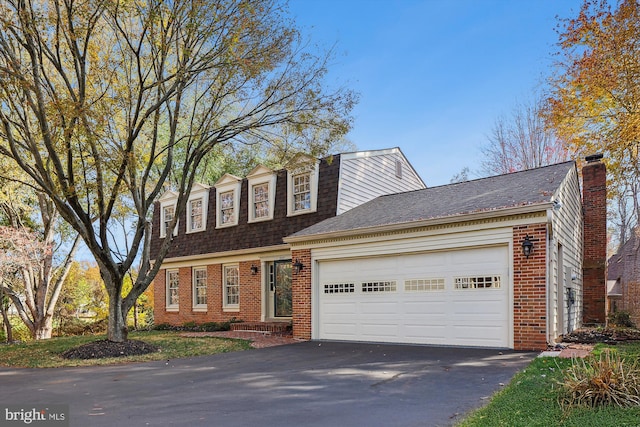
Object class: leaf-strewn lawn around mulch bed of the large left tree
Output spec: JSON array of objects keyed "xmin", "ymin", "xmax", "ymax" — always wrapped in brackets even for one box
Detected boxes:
[{"xmin": 0, "ymin": 331, "xmax": 251, "ymax": 368}]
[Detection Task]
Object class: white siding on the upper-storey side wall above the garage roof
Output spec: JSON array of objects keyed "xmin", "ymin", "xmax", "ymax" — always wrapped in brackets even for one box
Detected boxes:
[{"xmin": 336, "ymin": 148, "xmax": 425, "ymax": 215}]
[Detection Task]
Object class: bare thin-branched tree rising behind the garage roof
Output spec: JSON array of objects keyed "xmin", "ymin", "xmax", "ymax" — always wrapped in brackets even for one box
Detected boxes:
[{"xmin": 481, "ymin": 97, "xmax": 568, "ymax": 175}]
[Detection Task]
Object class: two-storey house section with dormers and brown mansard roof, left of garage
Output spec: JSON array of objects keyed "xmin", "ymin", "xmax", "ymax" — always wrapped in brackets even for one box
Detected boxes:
[{"xmin": 152, "ymin": 148, "xmax": 425, "ymax": 328}]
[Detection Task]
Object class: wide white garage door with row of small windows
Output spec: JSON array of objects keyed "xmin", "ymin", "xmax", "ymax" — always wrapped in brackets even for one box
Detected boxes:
[{"xmin": 317, "ymin": 246, "xmax": 510, "ymax": 347}]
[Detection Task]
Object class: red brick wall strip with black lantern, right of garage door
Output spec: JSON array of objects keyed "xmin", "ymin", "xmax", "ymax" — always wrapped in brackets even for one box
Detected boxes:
[{"xmin": 513, "ymin": 223, "xmax": 547, "ymax": 350}]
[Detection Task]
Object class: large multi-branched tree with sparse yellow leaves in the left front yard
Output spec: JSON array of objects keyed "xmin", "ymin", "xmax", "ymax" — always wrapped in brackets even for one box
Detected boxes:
[{"xmin": 0, "ymin": 0, "xmax": 354, "ymax": 341}]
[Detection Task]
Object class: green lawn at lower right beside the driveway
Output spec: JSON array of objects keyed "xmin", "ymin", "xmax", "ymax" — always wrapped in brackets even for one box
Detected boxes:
[{"xmin": 459, "ymin": 342, "xmax": 640, "ymax": 427}]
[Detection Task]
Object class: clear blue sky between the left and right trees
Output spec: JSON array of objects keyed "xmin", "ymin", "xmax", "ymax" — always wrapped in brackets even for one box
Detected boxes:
[{"xmin": 289, "ymin": 0, "xmax": 582, "ymax": 186}]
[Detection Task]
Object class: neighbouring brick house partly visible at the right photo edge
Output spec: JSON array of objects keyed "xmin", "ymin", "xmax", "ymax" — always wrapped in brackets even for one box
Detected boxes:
[{"xmin": 607, "ymin": 227, "xmax": 640, "ymax": 325}]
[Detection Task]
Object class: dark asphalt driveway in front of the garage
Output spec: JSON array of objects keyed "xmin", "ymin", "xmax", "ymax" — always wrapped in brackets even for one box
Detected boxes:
[{"xmin": 0, "ymin": 341, "xmax": 536, "ymax": 427}]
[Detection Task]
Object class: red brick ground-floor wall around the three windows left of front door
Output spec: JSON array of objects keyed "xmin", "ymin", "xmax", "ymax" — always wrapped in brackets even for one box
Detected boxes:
[{"xmin": 154, "ymin": 260, "xmax": 262, "ymax": 325}]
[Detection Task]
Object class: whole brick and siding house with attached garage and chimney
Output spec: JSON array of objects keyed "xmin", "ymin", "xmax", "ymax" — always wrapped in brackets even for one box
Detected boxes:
[{"xmin": 154, "ymin": 150, "xmax": 606, "ymax": 350}]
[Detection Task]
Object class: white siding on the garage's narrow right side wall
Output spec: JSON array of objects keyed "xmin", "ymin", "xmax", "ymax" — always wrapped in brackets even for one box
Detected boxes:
[{"xmin": 548, "ymin": 168, "xmax": 583, "ymax": 342}]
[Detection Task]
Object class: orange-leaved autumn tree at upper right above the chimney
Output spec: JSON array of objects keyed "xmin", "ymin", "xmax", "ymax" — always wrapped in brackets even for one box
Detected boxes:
[{"xmin": 547, "ymin": 0, "xmax": 640, "ymax": 242}]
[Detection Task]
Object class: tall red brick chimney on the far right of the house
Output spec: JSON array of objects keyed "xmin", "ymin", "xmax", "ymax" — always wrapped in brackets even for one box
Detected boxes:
[{"xmin": 582, "ymin": 154, "xmax": 607, "ymax": 324}]
